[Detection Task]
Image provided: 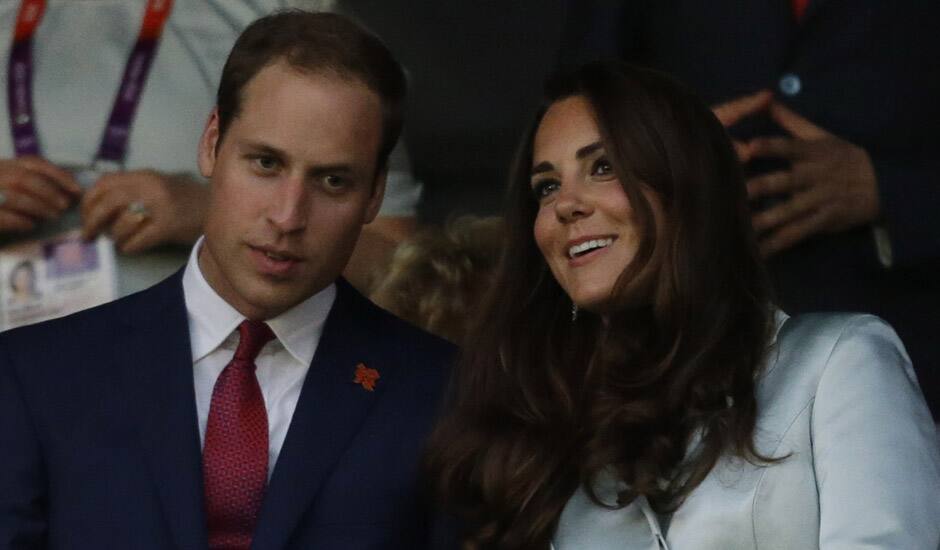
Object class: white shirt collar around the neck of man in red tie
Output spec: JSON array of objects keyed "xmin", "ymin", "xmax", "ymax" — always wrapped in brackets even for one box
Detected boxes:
[{"xmin": 183, "ymin": 237, "xmax": 336, "ymax": 365}]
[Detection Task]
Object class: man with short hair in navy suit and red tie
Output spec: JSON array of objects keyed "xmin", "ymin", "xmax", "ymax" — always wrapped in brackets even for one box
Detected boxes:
[{"xmin": 0, "ymin": 12, "xmax": 453, "ymax": 549}]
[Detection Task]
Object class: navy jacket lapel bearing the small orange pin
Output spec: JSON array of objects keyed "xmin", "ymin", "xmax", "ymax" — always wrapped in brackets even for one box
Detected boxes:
[{"xmin": 252, "ymin": 280, "xmax": 391, "ymax": 550}]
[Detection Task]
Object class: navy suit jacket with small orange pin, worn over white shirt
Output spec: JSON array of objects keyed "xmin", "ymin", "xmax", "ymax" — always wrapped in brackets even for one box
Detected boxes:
[{"xmin": 0, "ymin": 273, "xmax": 454, "ymax": 550}]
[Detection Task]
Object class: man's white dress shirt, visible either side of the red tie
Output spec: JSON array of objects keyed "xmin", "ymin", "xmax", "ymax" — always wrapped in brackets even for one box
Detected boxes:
[{"xmin": 183, "ymin": 238, "xmax": 336, "ymax": 478}]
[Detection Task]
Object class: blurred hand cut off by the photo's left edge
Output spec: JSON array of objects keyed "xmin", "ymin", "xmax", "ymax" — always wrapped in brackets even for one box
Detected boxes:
[{"xmin": 0, "ymin": 157, "xmax": 82, "ymax": 234}]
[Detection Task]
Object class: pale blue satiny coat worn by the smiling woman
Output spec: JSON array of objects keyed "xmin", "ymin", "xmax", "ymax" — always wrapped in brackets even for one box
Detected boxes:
[{"xmin": 553, "ymin": 314, "xmax": 940, "ymax": 550}]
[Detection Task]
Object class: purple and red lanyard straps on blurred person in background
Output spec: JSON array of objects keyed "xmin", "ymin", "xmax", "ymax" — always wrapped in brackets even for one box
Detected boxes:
[{"xmin": 7, "ymin": 0, "xmax": 173, "ymax": 165}]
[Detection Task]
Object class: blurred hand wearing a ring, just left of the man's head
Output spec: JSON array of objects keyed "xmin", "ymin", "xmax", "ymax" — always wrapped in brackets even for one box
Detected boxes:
[{"xmin": 81, "ymin": 170, "xmax": 209, "ymax": 254}]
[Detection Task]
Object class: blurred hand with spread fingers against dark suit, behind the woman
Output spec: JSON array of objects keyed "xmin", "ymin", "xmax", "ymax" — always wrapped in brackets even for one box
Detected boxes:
[{"xmin": 742, "ymin": 102, "xmax": 881, "ymax": 256}]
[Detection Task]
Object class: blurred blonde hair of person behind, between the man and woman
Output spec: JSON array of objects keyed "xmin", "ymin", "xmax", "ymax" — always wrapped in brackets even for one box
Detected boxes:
[{"xmin": 372, "ymin": 216, "xmax": 504, "ymax": 344}]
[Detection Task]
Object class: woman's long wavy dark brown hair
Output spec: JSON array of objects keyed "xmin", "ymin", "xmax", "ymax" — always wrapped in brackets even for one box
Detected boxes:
[{"xmin": 427, "ymin": 63, "xmax": 773, "ymax": 549}]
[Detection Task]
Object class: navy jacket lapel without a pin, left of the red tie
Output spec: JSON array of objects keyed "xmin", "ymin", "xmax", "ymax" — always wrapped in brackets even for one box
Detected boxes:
[{"xmin": 115, "ymin": 271, "xmax": 208, "ymax": 548}]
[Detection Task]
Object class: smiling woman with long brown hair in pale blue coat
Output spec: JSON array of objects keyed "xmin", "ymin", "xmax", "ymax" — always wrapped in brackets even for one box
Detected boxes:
[{"xmin": 428, "ymin": 64, "xmax": 940, "ymax": 550}]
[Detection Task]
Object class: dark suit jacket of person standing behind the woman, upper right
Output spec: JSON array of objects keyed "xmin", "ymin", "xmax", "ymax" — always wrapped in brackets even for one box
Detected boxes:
[{"xmin": 561, "ymin": 0, "xmax": 940, "ymax": 418}]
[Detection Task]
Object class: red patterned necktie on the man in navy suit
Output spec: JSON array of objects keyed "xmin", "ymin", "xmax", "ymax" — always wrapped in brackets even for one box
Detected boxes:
[{"xmin": 202, "ymin": 321, "xmax": 274, "ymax": 550}]
